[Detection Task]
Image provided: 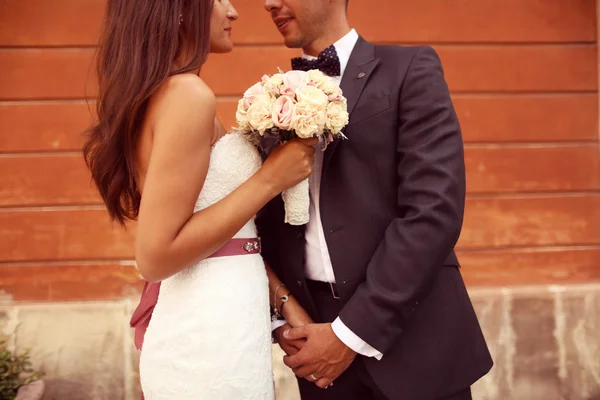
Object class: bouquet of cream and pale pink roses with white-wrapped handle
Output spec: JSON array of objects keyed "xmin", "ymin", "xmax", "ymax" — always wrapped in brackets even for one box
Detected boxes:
[{"xmin": 236, "ymin": 70, "xmax": 348, "ymax": 225}]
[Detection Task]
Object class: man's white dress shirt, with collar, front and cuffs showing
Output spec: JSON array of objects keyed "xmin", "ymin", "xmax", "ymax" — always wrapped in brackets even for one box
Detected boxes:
[{"xmin": 273, "ymin": 29, "xmax": 383, "ymax": 359}]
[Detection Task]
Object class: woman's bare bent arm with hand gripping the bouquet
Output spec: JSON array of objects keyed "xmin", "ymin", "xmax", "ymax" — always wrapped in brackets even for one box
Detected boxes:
[{"xmin": 136, "ymin": 75, "xmax": 314, "ymax": 282}]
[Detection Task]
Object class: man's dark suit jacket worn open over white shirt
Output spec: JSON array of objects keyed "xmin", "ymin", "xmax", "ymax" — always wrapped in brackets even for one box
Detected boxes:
[{"xmin": 257, "ymin": 38, "xmax": 492, "ymax": 400}]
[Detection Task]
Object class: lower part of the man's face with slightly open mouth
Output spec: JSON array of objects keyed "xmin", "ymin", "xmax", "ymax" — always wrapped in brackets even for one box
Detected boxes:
[{"xmin": 265, "ymin": 0, "xmax": 328, "ymax": 48}]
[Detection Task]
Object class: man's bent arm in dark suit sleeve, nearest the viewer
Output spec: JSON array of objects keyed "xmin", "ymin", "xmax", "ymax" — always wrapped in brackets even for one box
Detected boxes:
[{"xmin": 340, "ymin": 47, "xmax": 465, "ymax": 355}]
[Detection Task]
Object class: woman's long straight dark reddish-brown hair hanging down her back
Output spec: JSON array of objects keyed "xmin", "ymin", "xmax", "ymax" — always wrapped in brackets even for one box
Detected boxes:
[{"xmin": 83, "ymin": 0, "xmax": 214, "ymax": 226}]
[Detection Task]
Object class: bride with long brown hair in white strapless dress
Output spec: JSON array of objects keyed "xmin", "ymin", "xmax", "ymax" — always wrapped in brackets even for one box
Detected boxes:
[{"xmin": 84, "ymin": 0, "xmax": 315, "ymax": 400}]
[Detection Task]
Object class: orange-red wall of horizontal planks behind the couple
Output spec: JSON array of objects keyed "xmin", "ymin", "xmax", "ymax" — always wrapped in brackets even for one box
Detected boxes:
[{"xmin": 0, "ymin": 0, "xmax": 600, "ymax": 301}]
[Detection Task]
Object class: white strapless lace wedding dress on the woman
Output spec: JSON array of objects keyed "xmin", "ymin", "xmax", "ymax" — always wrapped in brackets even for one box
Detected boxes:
[{"xmin": 140, "ymin": 134, "xmax": 274, "ymax": 400}]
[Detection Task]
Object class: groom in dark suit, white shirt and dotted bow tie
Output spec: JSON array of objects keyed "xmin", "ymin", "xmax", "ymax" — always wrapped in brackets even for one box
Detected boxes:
[{"xmin": 257, "ymin": 0, "xmax": 493, "ymax": 400}]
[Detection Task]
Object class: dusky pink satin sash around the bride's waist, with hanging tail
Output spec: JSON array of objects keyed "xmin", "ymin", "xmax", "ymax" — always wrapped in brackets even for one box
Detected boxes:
[{"xmin": 129, "ymin": 238, "xmax": 261, "ymax": 350}]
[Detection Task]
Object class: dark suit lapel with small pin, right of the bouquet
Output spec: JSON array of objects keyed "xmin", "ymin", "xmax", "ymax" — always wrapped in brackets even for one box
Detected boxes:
[{"xmin": 323, "ymin": 37, "xmax": 379, "ymax": 172}]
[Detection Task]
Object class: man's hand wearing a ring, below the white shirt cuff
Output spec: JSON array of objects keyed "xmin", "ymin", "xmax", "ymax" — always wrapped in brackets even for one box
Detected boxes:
[{"xmin": 283, "ymin": 324, "xmax": 356, "ymax": 389}]
